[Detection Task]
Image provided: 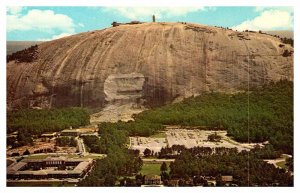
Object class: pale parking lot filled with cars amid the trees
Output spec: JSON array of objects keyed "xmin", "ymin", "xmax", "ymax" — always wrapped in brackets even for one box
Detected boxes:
[{"xmin": 129, "ymin": 129, "xmax": 263, "ymax": 152}]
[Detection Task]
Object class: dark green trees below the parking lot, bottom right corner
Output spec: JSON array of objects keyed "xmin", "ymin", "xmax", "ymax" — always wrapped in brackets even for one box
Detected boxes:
[{"xmin": 170, "ymin": 151, "xmax": 293, "ymax": 186}]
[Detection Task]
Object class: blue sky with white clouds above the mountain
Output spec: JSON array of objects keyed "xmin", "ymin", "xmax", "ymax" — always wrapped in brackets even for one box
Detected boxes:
[{"xmin": 6, "ymin": 6, "xmax": 294, "ymax": 41}]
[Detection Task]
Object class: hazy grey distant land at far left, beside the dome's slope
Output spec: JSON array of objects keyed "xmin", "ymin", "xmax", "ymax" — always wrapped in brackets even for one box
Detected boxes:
[{"xmin": 6, "ymin": 41, "xmax": 42, "ymax": 55}]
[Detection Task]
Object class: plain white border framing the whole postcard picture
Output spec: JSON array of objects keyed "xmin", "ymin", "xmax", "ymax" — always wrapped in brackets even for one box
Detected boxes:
[{"xmin": 0, "ymin": 0, "xmax": 300, "ymax": 193}]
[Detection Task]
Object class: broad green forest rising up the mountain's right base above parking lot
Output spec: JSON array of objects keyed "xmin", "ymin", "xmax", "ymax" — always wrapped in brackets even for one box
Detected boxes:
[{"xmin": 100, "ymin": 80, "xmax": 293, "ymax": 154}]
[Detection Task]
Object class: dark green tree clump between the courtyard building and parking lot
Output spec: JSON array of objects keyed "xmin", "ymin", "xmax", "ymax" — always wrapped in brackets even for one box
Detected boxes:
[{"xmin": 78, "ymin": 126, "xmax": 143, "ymax": 186}]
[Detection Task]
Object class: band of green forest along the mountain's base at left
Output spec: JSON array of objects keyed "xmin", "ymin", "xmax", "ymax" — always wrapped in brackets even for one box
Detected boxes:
[{"xmin": 7, "ymin": 108, "xmax": 90, "ymax": 135}]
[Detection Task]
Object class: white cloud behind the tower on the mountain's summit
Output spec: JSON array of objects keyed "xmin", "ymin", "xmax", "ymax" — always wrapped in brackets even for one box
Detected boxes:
[{"xmin": 104, "ymin": 7, "xmax": 205, "ymax": 20}]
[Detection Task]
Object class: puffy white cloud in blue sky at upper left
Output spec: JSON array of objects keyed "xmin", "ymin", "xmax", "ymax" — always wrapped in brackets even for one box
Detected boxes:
[{"xmin": 7, "ymin": 9, "xmax": 75, "ymax": 33}]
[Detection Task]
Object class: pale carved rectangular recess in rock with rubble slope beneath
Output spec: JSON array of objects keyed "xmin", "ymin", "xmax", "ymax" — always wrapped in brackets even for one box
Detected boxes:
[{"xmin": 91, "ymin": 73, "xmax": 146, "ymax": 123}]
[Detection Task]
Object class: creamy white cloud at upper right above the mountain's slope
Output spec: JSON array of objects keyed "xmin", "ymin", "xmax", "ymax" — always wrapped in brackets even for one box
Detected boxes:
[{"xmin": 232, "ymin": 9, "xmax": 294, "ymax": 31}]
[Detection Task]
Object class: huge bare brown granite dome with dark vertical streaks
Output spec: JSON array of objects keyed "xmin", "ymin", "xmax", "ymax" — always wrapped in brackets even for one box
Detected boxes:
[{"xmin": 7, "ymin": 23, "xmax": 293, "ymax": 109}]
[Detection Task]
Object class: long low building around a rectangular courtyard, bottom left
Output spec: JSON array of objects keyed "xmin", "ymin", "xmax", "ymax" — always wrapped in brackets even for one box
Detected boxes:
[{"xmin": 7, "ymin": 157, "xmax": 94, "ymax": 180}]
